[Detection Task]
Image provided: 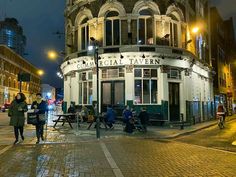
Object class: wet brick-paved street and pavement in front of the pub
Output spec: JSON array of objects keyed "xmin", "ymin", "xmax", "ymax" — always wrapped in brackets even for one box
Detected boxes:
[{"xmin": 0, "ymin": 112, "xmax": 236, "ymax": 177}]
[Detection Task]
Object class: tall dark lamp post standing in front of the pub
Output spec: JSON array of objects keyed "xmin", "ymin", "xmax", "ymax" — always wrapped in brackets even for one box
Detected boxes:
[{"xmin": 90, "ymin": 37, "xmax": 100, "ymax": 139}]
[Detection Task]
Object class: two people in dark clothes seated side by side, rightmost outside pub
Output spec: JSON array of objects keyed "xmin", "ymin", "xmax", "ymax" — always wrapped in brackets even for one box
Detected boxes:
[{"xmin": 123, "ymin": 106, "xmax": 149, "ymax": 133}]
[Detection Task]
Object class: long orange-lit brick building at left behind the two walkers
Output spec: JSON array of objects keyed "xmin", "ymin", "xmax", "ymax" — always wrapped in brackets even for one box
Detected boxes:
[{"xmin": 0, "ymin": 45, "xmax": 41, "ymax": 105}]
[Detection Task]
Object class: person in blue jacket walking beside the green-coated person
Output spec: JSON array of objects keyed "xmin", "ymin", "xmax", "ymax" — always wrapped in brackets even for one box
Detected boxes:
[{"xmin": 31, "ymin": 93, "xmax": 48, "ymax": 144}]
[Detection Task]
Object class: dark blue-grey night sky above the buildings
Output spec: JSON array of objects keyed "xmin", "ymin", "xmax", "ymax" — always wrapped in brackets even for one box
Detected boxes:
[{"xmin": 0, "ymin": 0, "xmax": 236, "ymax": 87}]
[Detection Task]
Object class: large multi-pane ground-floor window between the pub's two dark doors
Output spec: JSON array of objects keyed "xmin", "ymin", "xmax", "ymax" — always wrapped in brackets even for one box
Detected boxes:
[{"xmin": 134, "ymin": 69, "xmax": 157, "ymax": 104}]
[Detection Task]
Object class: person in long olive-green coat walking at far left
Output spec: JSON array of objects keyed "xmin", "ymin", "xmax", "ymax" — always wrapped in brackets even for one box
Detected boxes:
[{"xmin": 8, "ymin": 93, "xmax": 28, "ymax": 144}]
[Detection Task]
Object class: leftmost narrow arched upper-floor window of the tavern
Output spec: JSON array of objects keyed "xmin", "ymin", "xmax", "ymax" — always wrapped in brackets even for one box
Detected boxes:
[{"xmin": 80, "ymin": 18, "xmax": 89, "ymax": 50}]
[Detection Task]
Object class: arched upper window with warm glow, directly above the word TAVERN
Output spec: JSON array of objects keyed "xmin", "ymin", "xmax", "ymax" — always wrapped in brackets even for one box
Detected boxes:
[{"xmin": 138, "ymin": 9, "xmax": 153, "ymax": 44}]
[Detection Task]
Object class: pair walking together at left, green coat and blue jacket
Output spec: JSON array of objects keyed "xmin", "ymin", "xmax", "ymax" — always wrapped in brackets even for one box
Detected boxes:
[{"xmin": 8, "ymin": 93, "xmax": 48, "ymax": 144}]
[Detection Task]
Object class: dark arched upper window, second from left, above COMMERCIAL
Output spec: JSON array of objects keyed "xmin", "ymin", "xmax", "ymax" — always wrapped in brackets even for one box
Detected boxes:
[{"xmin": 105, "ymin": 11, "xmax": 120, "ymax": 46}]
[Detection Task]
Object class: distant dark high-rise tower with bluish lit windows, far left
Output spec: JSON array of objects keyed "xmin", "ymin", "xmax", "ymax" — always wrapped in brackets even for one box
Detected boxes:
[{"xmin": 0, "ymin": 18, "xmax": 26, "ymax": 56}]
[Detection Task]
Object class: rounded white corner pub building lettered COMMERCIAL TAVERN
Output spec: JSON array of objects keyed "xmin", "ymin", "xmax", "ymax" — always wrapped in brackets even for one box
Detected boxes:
[{"xmin": 61, "ymin": 0, "xmax": 214, "ymax": 124}]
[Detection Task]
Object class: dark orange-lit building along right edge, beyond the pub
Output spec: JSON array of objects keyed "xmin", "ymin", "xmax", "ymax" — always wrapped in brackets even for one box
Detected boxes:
[{"xmin": 210, "ymin": 7, "xmax": 236, "ymax": 115}]
